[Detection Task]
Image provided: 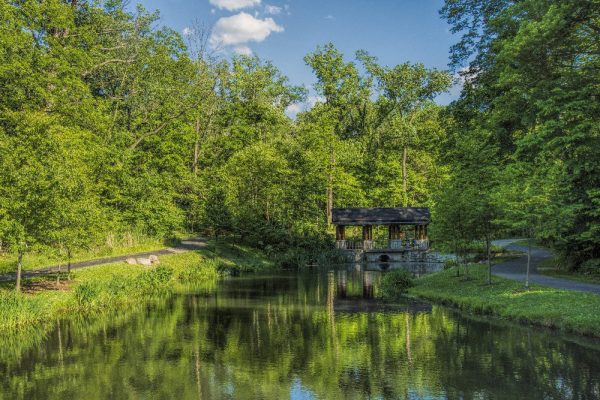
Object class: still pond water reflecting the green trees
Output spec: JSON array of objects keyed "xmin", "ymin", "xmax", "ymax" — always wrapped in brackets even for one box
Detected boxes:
[{"xmin": 0, "ymin": 267, "xmax": 600, "ymax": 399}]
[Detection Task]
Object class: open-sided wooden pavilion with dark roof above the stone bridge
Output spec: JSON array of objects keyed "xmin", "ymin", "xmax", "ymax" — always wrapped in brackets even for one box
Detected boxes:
[{"xmin": 332, "ymin": 207, "xmax": 431, "ymax": 251}]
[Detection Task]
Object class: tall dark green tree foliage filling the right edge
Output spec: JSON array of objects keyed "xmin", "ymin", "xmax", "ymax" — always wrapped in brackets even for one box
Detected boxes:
[{"xmin": 441, "ymin": 0, "xmax": 600, "ymax": 268}]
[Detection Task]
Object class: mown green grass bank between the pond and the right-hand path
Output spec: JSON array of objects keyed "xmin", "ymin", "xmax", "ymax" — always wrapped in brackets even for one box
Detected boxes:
[{"xmin": 408, "ymin": 265, "xmax": 600, "ymax": 337}]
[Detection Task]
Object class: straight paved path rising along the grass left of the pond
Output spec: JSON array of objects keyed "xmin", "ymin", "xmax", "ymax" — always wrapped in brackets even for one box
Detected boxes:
[{"xmin": 0, "ymin": 238, "xmax": 208, "ymax": 282}]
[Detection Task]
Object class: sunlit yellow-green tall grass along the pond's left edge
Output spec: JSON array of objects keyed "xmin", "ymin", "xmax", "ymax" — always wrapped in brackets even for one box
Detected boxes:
[{"xmin": 0, "ymin": 253, "xmax": 224, "ymax": 332}]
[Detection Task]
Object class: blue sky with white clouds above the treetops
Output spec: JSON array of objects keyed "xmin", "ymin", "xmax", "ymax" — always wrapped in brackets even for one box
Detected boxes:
[{"xmin": 132, "ymin": 0, "xmax": 459, "ymax": 116}]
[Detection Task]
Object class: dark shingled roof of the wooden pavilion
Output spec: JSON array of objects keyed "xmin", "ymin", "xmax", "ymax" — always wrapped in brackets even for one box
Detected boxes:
[{"xmin": 332, "ymin": 207, "xmax": 431, "ymax": 225}]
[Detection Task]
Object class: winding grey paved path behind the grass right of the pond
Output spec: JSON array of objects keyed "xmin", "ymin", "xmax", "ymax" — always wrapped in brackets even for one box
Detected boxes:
[{"xmin": 492, "ymin": 239, "xmax": 600, "ymax": 294}]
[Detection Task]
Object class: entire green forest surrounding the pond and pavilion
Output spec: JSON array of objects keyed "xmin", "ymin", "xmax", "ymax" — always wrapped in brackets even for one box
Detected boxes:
[{"xmin": 0, "ymin": 0, "xmax": 600, "ymax": 288}]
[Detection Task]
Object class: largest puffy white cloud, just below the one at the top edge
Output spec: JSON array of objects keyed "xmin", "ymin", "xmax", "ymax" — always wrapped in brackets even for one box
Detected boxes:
[{"xmin": 210, "ymin": 12, "xmax": 283, "ymax": 47}]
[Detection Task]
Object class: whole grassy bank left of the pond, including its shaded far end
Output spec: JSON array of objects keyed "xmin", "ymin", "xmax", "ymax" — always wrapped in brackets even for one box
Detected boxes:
[{"xmin": 0, "ymin": 244, "xmax": 270, "ymax": 333}]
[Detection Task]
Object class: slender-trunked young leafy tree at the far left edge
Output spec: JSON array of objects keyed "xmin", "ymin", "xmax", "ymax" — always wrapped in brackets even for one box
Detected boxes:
[{"xmin": 0, "ymin": 113, "xmax": 68, "ymax": 291}]
